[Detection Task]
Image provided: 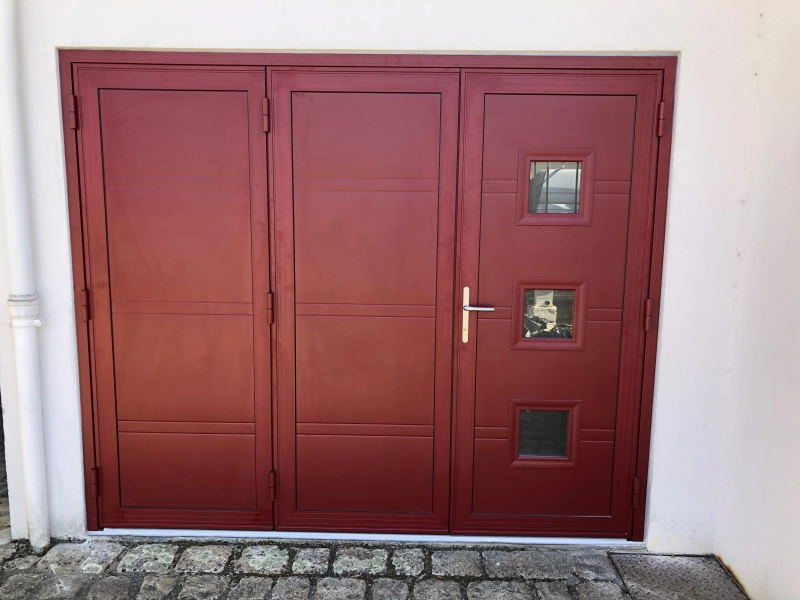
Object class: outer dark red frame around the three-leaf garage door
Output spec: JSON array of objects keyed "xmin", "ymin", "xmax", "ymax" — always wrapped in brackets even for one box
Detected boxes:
[{"xmin": 59, "ymin": 50, "xmax": 677, "ymax": 541}]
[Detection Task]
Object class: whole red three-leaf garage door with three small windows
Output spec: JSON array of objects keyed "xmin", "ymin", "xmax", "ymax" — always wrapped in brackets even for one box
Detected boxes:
[{"xmin": 72, "ymin": 55, "xmax": 664, "ymax": 537}]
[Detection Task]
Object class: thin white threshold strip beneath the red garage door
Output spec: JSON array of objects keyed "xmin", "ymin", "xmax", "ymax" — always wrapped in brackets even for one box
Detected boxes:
[{"xmin": 92, "ymin": 528, "xmax": 645, "ymax": 548}]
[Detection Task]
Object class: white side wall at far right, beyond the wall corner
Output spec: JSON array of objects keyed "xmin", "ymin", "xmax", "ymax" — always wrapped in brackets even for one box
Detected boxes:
[{"xmin": 716, "ymin": 0, "xmax": 800, "ymax": 600}]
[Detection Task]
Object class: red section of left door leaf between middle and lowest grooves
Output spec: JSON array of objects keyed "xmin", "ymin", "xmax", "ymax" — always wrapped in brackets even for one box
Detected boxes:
[{"xmin": 113, "ymin": 314, "xmax": 255, "ymax": 422}]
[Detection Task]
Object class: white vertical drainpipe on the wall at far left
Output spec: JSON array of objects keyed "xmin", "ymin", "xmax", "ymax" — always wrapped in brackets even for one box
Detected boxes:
[{"xmin": 0, "ymin": 0, "xmax": 50, "ymax": 549}]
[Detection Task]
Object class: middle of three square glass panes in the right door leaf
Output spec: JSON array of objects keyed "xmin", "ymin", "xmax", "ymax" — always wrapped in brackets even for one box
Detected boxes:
[{"xmin": 522, "ymin": 290, "xmax": 575, "ymax": 338}]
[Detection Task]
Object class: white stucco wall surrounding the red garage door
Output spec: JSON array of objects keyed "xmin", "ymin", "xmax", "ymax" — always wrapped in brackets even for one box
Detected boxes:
[{"xmin": 0, "ymin": 0, "xmax": 800, "ymax": 600}]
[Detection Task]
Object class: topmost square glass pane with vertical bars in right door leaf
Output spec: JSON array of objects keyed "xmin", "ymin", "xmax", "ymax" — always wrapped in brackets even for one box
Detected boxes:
[{"xmin": 528, "ymin": 161, "xmax": 582, "ymax": 215}]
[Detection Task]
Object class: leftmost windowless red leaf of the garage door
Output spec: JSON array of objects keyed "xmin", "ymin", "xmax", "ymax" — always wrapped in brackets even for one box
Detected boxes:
[{"xmin": 76, "ymin": 67, "xmax": 272, "ymax": 528}]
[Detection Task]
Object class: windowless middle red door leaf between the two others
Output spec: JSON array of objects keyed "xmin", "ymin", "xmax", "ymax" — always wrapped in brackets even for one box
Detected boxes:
[{"xmin": 271, "ymin": 70, "xmax": 458, "ymax": 531}]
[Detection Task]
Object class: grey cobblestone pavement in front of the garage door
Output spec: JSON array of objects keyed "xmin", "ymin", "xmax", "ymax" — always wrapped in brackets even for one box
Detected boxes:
[{"xmin": 0, "ymin": 538, "xmax": 746, "ymax": 600}]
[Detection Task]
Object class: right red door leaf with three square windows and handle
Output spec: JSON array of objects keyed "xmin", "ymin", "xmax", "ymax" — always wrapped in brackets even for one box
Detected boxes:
[{"xmin": 452, "ymin": 72, "xmax": 657, "ymax": 537}]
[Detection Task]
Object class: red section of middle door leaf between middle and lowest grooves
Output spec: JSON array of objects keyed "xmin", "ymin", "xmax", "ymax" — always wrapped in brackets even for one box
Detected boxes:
[{"xmin": 296, "ymin": 316, "xmax": 436, "ymax": 425}]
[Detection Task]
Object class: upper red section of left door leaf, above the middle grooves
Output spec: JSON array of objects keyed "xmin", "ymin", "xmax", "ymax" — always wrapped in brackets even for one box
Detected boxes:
[{"xmin": 99, "ymin": 90, "xmax": 253, "ymax": 302}]
